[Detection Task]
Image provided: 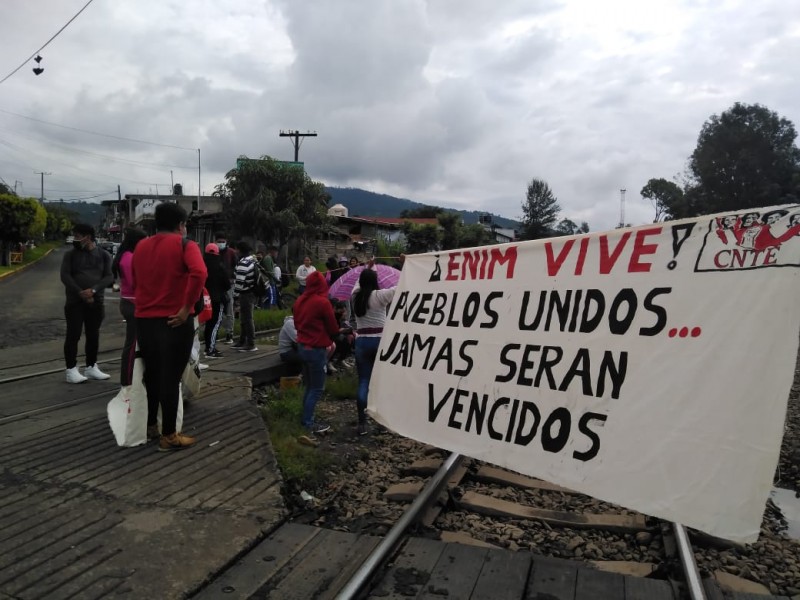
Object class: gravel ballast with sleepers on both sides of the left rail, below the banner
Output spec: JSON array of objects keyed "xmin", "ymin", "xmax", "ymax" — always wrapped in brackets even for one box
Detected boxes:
[{"xmin": 257, "ymin": 378, "xmax": 797, "ymax": 597}]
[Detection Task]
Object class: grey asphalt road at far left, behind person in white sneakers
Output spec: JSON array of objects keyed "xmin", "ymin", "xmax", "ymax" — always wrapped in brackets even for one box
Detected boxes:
[{"xmin": 0, "ymin": 245, "xmax": 124, "ymax": 350}]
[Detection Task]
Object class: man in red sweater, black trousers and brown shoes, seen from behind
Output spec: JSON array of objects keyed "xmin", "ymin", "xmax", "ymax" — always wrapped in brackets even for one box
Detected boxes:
[{"xmin": 133, "ymin": 203, "xmax": 206, "ymax": 451}]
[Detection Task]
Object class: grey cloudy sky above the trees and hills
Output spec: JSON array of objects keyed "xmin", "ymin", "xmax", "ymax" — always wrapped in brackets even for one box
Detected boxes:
[{"xmin": 0, "ymin": 0, "xmax": 800, "ymax": 231}]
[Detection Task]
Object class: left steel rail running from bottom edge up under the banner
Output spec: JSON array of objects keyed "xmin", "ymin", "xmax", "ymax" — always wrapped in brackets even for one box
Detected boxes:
[{"xmin": 336, "ymin": 452, "xmax": 463, "ymax": 600}]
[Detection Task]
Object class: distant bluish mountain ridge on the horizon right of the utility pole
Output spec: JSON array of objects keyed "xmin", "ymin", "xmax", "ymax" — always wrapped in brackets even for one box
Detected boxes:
[{"xmin": 325, "ymin": 187, "xmax": 520, "ymax": 229}]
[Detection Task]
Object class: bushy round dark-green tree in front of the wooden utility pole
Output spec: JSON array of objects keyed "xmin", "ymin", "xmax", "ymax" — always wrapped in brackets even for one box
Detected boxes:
[{"xmin": 214, "ymin": 156, "xmax": 330, "ymax": 254}]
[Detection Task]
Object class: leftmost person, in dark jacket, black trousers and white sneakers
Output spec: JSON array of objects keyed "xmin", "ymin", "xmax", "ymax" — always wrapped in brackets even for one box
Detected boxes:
[{"xmin": 61, "ymin": 223, "xmax": 114, "ymax": 383}]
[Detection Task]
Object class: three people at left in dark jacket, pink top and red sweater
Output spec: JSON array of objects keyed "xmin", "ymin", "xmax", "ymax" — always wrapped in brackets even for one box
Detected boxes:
[{"xmin": 61, "ymin": 203, "xmax": 208, "ymax": 451}]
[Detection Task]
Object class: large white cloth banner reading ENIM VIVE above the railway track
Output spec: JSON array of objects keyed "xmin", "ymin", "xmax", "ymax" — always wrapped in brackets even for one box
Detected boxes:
[{"xmin": 369, "ymin": 205, "xmax": 800, "ymax": 542}]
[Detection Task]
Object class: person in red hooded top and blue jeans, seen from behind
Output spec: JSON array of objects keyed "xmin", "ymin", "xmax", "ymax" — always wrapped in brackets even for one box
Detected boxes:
[{"xmin": 294, "ymin": 271, "xmax": 339, "ymax": 436}]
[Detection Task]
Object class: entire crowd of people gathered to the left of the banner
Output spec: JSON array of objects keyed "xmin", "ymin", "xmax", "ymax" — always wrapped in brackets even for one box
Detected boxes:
[{"xmin": 61, "ymin": 203, "xmax": 394, "ymax": 451}]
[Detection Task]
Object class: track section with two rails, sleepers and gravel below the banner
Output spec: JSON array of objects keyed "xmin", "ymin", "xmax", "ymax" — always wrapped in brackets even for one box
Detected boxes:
[{"xmin": 342, "ymin": 449, "xmax": 704, "ymax": 599}]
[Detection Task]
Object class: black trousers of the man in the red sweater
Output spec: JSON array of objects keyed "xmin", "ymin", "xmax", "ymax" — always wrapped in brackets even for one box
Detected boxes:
[{"xmin": 136, "ymin": 317, "xmax": 194, "ymax": 435}]
